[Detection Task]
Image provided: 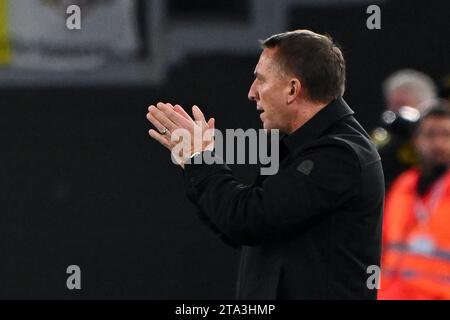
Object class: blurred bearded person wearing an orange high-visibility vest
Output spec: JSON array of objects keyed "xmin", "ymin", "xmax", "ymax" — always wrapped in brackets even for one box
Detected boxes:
[{"xmin": 379, "ymin": 101, "xmax": 450, "ymax": 300}]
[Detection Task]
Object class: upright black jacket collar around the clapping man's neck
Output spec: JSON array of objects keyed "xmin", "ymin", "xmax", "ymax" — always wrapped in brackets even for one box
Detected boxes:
[{"xmin": 281, "ymin": 97, "xmax": 354, "ymax": 151}]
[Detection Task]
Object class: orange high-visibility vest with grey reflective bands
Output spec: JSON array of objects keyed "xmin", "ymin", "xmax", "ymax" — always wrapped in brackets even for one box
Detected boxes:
[{"xmin": 378, "ymin": 169, "xmax": 450, "ymax": 299}]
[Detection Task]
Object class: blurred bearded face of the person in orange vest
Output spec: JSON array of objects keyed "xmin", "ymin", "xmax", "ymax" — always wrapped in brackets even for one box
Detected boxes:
[{"xmin": 415, "ymin": 116, "xmax": 450, "ymax": 165}]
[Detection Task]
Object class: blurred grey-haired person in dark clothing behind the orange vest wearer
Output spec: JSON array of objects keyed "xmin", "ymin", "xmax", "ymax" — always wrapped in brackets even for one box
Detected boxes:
[{"xmin": 372, "ymin": 69, "xmax": 437, "ymax": 188}]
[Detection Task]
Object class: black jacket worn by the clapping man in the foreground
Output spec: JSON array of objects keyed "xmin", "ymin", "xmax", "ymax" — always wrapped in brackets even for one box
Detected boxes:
[{"xmin": 184, "ymin": 98, "xmax": 384, "ymax": 299}]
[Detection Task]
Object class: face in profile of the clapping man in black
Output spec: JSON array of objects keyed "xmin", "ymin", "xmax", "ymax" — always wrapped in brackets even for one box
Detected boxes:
[{"xmin": 248, "ymin": 48, "xmax": 293, "ymax": 132}]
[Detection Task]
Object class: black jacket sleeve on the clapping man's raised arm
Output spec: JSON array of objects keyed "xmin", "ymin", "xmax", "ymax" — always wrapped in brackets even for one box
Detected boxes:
[{"xmin": 184, "ymin": 145, "xmax": 360, "ymax": 246}]
